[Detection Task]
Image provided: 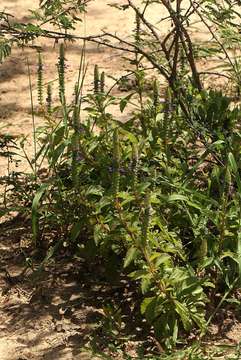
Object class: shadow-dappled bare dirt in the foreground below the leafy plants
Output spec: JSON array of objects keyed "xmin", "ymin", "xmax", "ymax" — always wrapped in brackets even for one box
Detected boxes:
[{"xmin": 0, "ymin": 216, "xmax": 241, "ymax": 360}]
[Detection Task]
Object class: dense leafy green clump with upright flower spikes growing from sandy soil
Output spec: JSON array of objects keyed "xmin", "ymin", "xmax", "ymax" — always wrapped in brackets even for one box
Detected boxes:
[{"xmin": 5, "ymin": 47, "xmax": 237, "ymax": 347}]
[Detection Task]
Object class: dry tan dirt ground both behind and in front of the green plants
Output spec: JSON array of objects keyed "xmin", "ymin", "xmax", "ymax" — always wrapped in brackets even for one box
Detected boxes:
[{"xmin": 0, "ymin": 0, "xmax": 241, "ymax": 360}]
